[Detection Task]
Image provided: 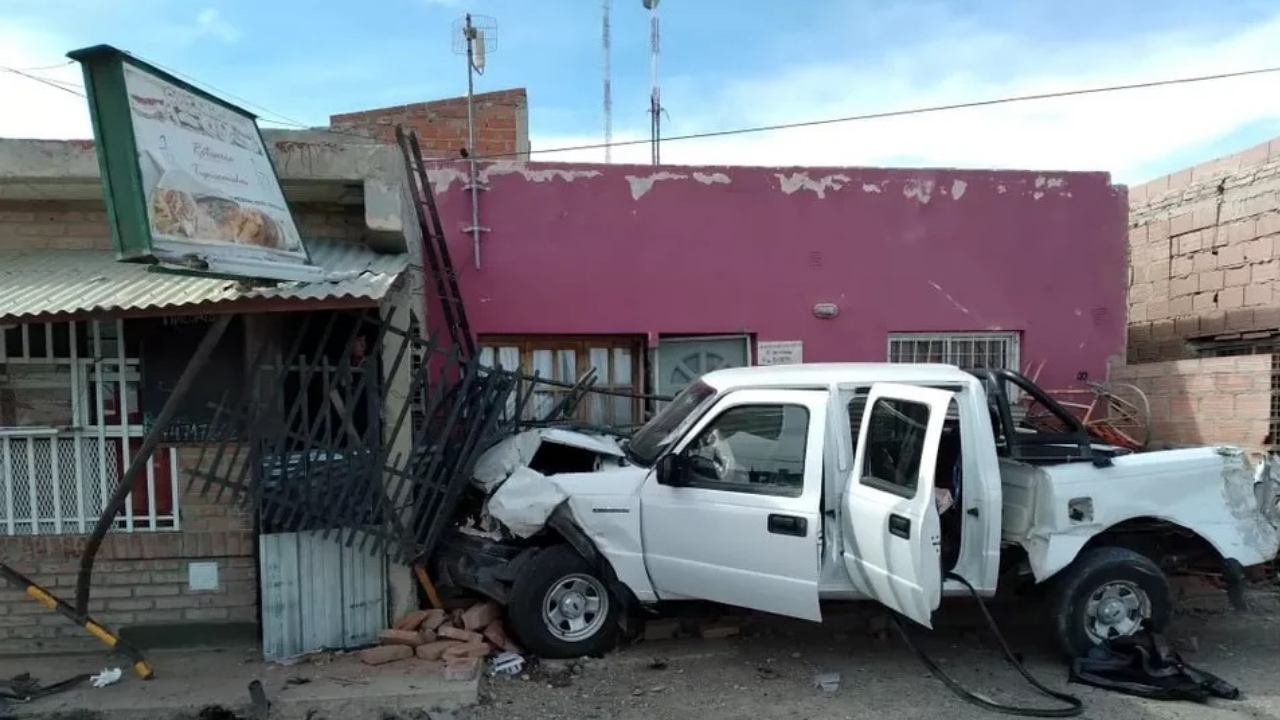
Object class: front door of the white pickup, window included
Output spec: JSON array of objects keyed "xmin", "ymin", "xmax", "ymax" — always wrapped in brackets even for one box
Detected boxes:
[{"xmin": 640, "ymin": 389, "xmax": 828, "ymax": 620}]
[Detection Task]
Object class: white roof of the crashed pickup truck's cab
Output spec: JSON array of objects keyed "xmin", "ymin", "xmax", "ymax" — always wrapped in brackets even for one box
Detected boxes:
[{"xmin": 701, "ymin": 363, "xmax": 980, "ymax": 391}]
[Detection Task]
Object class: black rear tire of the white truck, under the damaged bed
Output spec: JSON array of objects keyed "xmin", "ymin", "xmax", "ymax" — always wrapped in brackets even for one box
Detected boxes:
[{"xmin": 1050, "ymin": 547, "xmax": 1172, "ymax": 659}]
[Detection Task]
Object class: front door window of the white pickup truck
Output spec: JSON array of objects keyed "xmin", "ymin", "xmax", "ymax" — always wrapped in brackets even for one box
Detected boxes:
[{"xmin": 684, "ymin": 405, "xmax": 809, "ymax": 497}]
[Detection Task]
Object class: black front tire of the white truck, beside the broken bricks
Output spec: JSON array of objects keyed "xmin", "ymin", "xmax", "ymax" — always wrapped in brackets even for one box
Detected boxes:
[{"xmin": 507, "ymin": 544, "xmax": 622, "ymax": 660}]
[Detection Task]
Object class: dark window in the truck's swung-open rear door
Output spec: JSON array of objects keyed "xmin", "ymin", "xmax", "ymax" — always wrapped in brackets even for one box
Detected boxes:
[{"xmin": 861, "ymin": 397, "xmax": 929, "ymax": 497}]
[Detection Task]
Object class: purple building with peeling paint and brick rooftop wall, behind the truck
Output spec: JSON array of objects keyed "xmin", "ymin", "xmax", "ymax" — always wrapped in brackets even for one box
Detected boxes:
[{"xmin": 330, "ymin": 90, "xmax": 1128, "ymax": 415}]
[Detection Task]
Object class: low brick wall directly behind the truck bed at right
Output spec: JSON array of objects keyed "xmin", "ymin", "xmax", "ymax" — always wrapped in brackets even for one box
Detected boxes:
[{"xmin": 1110, "ymin": 355, "xmax": 1272, "ymax": 450}]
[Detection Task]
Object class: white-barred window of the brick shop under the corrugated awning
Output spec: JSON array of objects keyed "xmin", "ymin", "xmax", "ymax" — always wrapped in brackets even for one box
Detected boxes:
[{"xmin": 0, "ymin": 320, "xmax": 178, "ymax": 536}]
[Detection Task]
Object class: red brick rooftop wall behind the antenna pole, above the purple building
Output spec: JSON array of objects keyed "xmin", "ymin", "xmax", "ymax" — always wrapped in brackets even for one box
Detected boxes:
[{"xmin": 329, "ymin": 88, "xmax": 529, "ymax": 159}]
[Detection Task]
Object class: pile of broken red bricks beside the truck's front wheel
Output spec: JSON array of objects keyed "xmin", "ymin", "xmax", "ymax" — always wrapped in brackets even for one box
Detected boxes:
[{"xmin": 360, "ymin": 601, "xmax": 521, "ymax": 680}]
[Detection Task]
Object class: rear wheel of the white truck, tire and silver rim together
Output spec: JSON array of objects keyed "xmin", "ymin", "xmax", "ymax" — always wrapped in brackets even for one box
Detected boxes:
[{"xmin": 1052, "ymin": 547, "xmax": 1172, "ymax": 657}]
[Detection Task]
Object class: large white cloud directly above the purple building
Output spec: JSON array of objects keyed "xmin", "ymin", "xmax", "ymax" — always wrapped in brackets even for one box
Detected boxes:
[{"xmin": 531, "ymin": 13, "xmax": 1280, "ymax": 182}]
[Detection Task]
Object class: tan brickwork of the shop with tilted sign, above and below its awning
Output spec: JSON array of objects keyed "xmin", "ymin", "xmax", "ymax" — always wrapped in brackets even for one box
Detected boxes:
[{"xmin": 0, "ymin": 201, "xmax": 366, "ymax": 655}]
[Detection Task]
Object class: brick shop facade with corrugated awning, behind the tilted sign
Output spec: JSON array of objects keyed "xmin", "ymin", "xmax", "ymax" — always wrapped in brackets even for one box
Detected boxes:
[{"xmin": 0, "ymin": 132, "xmax": 422, "ymax": 653}]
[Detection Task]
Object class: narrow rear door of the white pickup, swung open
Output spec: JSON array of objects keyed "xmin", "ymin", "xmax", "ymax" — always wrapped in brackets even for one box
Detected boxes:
[{"xmin": 844, "ymin": 383, "xmax": 952, "ymax": 628}]
